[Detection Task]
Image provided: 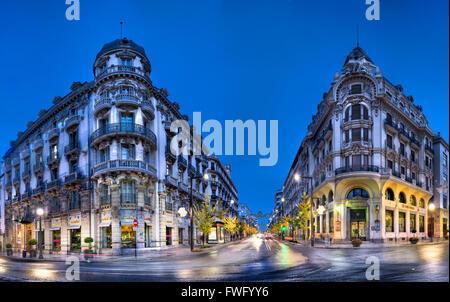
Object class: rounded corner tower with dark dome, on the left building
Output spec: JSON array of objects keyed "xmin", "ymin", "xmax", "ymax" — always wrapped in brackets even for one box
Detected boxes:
[{"xmin": 89, "ymin": 38, "xmax": 157, "ymax": 254}]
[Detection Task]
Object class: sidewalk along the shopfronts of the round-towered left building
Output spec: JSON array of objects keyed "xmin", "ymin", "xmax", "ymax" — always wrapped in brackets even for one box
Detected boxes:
[{"xmin": 0, "ymin": 238, "xmax": 246, "ymax": 262}]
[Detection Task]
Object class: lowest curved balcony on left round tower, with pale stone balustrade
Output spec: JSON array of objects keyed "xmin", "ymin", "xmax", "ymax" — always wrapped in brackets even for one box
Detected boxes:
[{"xmin": 92, "ymin": 159, "xmax": 156, "ymax": 177}]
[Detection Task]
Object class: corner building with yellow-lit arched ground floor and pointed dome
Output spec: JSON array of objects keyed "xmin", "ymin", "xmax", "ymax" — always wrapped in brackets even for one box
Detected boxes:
[{"xmin": 283, "ymin": 46, "xmax": 442, "ymax": 242}]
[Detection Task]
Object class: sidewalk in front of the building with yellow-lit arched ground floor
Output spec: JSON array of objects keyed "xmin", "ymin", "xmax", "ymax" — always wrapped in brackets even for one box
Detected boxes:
[{"xmin": 279, "ymin": 240, "xmax": 448, "ymax": 249}]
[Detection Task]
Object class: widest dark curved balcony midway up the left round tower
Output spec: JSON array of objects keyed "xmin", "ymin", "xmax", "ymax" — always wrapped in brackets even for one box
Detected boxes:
[{"xmin": 90, "ymin": 123, "xmax": 156, "ymax": 148}]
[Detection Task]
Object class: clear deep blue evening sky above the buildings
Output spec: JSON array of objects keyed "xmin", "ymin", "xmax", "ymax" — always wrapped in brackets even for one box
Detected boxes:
[{"xmin": 0, "ymin": 0, "xmax": 449, "ymax": 226}]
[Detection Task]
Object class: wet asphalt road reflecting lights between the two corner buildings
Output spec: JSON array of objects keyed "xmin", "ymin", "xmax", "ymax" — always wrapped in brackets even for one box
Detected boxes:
[{"xmin": 0, "ymin": 237, "xmax": 449, "ymax": 282}]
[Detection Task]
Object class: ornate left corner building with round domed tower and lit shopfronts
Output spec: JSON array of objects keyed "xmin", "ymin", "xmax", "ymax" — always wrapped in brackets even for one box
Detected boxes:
[{"xmin": 1, "ymin": 38, "xmax": 239, "ymax": 255}]
